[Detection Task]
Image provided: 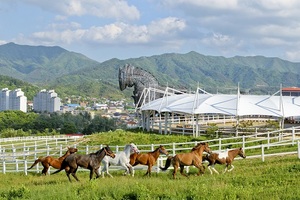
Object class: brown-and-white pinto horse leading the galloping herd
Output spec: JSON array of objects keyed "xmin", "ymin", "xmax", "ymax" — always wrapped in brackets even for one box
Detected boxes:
[{"xmin": 203, "ymin": 148, "xmax": 246, "ymax": 174}]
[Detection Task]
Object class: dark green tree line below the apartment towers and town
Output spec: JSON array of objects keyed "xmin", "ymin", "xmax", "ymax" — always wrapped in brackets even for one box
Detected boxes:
[{"xmin": 0, "ymin": 110, "xmax": 123, "ymax": 137}]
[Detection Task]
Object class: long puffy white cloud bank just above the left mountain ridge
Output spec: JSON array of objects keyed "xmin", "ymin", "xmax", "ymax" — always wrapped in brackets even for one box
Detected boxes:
[{"xmin": 23, "ymin": 18, "xmax": 185, "ymax": 45}]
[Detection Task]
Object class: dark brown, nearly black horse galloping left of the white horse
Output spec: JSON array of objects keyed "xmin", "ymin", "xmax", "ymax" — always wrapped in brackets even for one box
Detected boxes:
[{"xmin": 52, "ymin": 146, "xmax": 115, "ymax": 182}]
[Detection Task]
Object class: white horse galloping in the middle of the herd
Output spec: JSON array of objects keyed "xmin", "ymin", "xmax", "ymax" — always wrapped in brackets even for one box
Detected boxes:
[{"xmin": 101, "ymin": 143, "xmax": 140, "ymax": 178}]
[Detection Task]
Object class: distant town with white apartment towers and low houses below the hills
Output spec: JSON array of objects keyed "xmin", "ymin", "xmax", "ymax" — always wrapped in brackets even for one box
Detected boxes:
[{"xmin": 0, "ymin": 88, "xmax": 138, "ymax": 128}]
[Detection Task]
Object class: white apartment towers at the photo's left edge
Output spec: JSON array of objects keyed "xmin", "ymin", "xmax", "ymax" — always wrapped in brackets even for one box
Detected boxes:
[{"xmin": 0, "ymin": 88, "xmax": 27, "ymax": 112}]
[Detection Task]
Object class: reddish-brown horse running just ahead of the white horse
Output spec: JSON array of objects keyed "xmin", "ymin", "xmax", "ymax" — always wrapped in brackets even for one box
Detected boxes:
[{"xmin": 130, "ymin": 145, "xmax": 169, "ymax": 176}]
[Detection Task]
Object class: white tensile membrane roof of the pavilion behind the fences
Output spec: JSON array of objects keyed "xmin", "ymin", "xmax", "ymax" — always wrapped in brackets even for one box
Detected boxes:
[{"xmin": 140, "ymin": 93, "xmax": 300, "ymax": 117}]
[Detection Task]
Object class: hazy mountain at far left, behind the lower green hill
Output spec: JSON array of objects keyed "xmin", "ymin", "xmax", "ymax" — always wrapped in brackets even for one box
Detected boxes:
[{"xmin": 0, "ymin": 43, "xmax": 99, "ymax": 84}]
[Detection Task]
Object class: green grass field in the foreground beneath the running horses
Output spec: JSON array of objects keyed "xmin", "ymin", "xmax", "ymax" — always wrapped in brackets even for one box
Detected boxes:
[{"xmin": 0, "ymin": 155, "xmax": 300, "ymax": 200}]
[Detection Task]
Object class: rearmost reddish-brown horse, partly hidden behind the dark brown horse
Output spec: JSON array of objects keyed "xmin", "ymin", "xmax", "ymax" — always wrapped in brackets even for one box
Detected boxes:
[{"xmin": 28, "ymin": 147, "xmax": 77, "ymax": 175}]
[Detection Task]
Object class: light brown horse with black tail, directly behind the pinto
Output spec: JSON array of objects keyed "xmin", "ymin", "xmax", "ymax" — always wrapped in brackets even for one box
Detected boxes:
[{"xmin": 160, "ymin": 143, "xmax": 211, "ymax": 179}]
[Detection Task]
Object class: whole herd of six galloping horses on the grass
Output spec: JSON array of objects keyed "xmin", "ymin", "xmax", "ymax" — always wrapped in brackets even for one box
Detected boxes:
[{"xmin": 29, "ymin": 142, "xmax": 246, "ymax": 182}]
